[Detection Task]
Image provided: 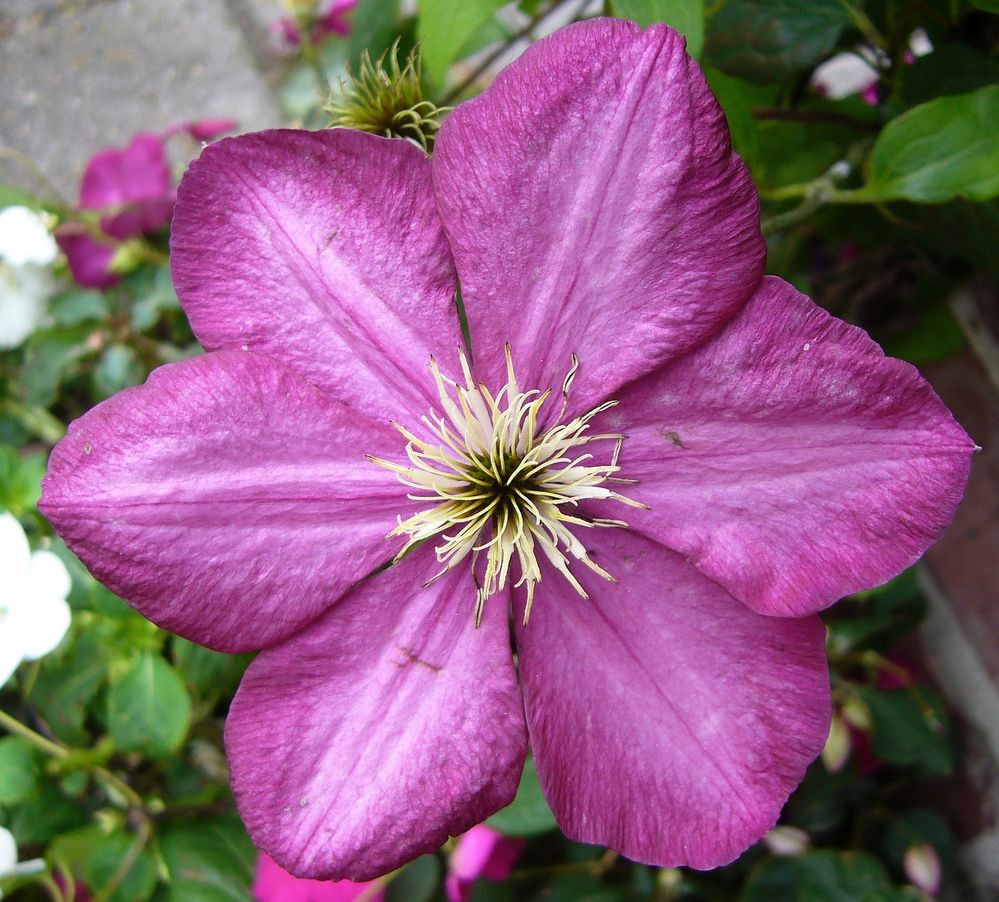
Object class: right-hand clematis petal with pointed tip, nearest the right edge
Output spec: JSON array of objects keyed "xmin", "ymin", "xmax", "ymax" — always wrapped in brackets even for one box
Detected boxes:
[{"xmin": 601, "ymin": 277, "xmax": 974, "ymax": 615}]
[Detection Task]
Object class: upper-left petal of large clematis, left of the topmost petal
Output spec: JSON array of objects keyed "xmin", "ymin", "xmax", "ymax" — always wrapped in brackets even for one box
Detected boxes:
[{"xmin": 171, "ymin": 129, "xmax": 461, "ymax": 418}]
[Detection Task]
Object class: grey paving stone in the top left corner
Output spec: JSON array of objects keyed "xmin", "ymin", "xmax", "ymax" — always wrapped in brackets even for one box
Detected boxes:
[{"xmin": 0, "ymin": 0, "xmax": 281, "ymax": 198}]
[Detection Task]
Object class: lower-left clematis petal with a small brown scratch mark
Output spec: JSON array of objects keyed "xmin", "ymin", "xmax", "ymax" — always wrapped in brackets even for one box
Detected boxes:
[{"xmin": 226, "ymin": 547, "xmax": 527, "ymax": 880}]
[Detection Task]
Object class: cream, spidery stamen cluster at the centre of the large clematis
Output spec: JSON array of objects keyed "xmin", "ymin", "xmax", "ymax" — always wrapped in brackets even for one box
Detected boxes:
[{"xmin": 369, "ymin": 345, "xmax": 647, "ymax": 624}]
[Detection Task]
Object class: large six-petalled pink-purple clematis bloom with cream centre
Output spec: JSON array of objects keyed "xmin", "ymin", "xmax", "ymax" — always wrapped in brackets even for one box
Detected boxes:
[{"xmin": 41, "ymin": 19, "xmax": 973, "ymax": 880}]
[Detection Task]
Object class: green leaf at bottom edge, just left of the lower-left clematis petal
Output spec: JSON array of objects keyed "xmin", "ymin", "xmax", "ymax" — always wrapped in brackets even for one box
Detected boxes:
[{"xmin": 160, "ymin": 815, "xmax": 256, "ymax": 902}]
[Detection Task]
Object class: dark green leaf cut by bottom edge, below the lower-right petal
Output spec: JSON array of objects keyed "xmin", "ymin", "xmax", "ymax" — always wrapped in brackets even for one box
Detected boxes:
[{"xmin": 739, "ymin": 849, "xmax": 919, "ymax": 902}]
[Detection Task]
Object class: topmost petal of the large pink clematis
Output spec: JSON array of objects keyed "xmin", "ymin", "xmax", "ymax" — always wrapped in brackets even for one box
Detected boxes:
[{"xmin": 433, "ymin": 19, "xmax": 765, "ymax": 410}]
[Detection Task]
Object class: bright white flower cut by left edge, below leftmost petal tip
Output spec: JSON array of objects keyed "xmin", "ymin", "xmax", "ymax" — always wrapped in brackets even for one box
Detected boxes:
[{"xmin": 0, "ymin": 513, "xmax": 70, "ymax": 686}]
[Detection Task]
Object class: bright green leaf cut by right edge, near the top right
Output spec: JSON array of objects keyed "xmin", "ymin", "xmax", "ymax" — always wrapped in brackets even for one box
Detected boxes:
[{"xmin": 857, "ymin": 85, "xmax": 999, "ymax": 203}]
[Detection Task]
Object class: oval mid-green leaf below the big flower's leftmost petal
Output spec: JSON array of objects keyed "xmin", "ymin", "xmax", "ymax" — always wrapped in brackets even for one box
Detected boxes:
[{"xmin": 108, "ymin": 652, "xmax": 191, "ymax": 756}]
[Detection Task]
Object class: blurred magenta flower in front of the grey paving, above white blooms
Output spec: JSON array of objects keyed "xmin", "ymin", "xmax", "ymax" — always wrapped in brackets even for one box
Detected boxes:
[{"xmin": 56, "ymin": 119, "xmax": 236, "ymax": 288}]
